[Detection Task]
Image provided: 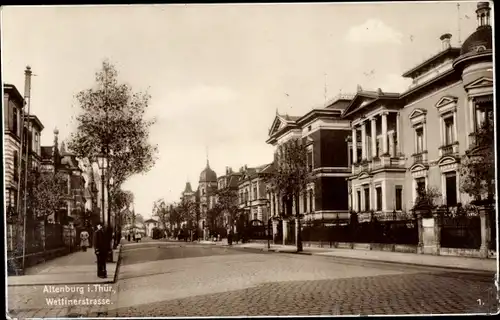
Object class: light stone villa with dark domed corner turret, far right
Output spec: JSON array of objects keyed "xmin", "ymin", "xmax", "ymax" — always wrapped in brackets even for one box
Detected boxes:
[{"xmin": 399, "ymin": 2, "xmax": 493, "ymax": 210}]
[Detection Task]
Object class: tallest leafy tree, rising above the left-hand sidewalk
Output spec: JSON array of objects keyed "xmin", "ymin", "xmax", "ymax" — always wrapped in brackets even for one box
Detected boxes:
[{"xmin": 68, "ymin": 61, "xmax": 157, "ymax": 228}]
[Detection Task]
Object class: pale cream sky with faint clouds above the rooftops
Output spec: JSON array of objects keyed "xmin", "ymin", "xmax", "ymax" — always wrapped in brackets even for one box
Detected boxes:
[{"xmin": 1, "ymin": 1, "xmax": 477, "ymax": 218}]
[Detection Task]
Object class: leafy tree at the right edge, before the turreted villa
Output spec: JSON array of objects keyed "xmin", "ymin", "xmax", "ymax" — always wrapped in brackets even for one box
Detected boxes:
[{"xmin": 460, "ymin": 112, "xmax": 495, "ymax": 203}]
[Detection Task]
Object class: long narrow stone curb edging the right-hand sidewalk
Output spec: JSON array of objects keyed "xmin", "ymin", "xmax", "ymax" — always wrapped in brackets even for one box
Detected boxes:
[{"xmin": 233, "ymin": 247, "xmax": 496, "ymax": 273}]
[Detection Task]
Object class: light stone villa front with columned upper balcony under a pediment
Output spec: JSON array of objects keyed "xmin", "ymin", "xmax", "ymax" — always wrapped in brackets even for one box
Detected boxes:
[{"xmin": 343, "ymin": 86, "xmax": 406, "ymax": 220}]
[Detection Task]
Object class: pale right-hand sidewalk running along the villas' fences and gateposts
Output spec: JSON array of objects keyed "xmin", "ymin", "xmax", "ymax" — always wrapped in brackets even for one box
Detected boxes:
[{"xmin": 200, "ymin": 239, "xmax": 497, "ymax": 272}]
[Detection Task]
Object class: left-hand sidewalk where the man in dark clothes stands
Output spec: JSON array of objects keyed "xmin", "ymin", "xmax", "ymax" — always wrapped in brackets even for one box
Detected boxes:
[{"xmin": 7, "ymin": 248, "xmax": 119, "ymax": 287}]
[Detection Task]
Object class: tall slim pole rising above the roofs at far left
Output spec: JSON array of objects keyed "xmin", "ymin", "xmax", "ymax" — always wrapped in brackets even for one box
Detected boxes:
[{"xmin": 21, "ymin": 66, "xmax": 32, "ymax": 270}]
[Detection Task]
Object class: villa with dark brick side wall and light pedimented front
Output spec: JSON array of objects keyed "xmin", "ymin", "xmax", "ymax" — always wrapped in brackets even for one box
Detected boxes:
[{"xmin": 267, "ymin": 95, "xmax": 353, "ymax": 226}]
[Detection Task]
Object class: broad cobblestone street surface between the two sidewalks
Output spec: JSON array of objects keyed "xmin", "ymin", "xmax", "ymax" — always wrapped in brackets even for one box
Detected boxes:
[{"xmin": 110, "ymin": 245, "xmax": 496, "ymax": 316}]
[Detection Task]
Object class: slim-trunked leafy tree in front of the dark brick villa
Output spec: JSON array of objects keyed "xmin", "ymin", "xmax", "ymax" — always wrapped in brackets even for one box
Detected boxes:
[{"xmin": 268, "ymin": 139, "xmax": 310, "ymax": 252}]
